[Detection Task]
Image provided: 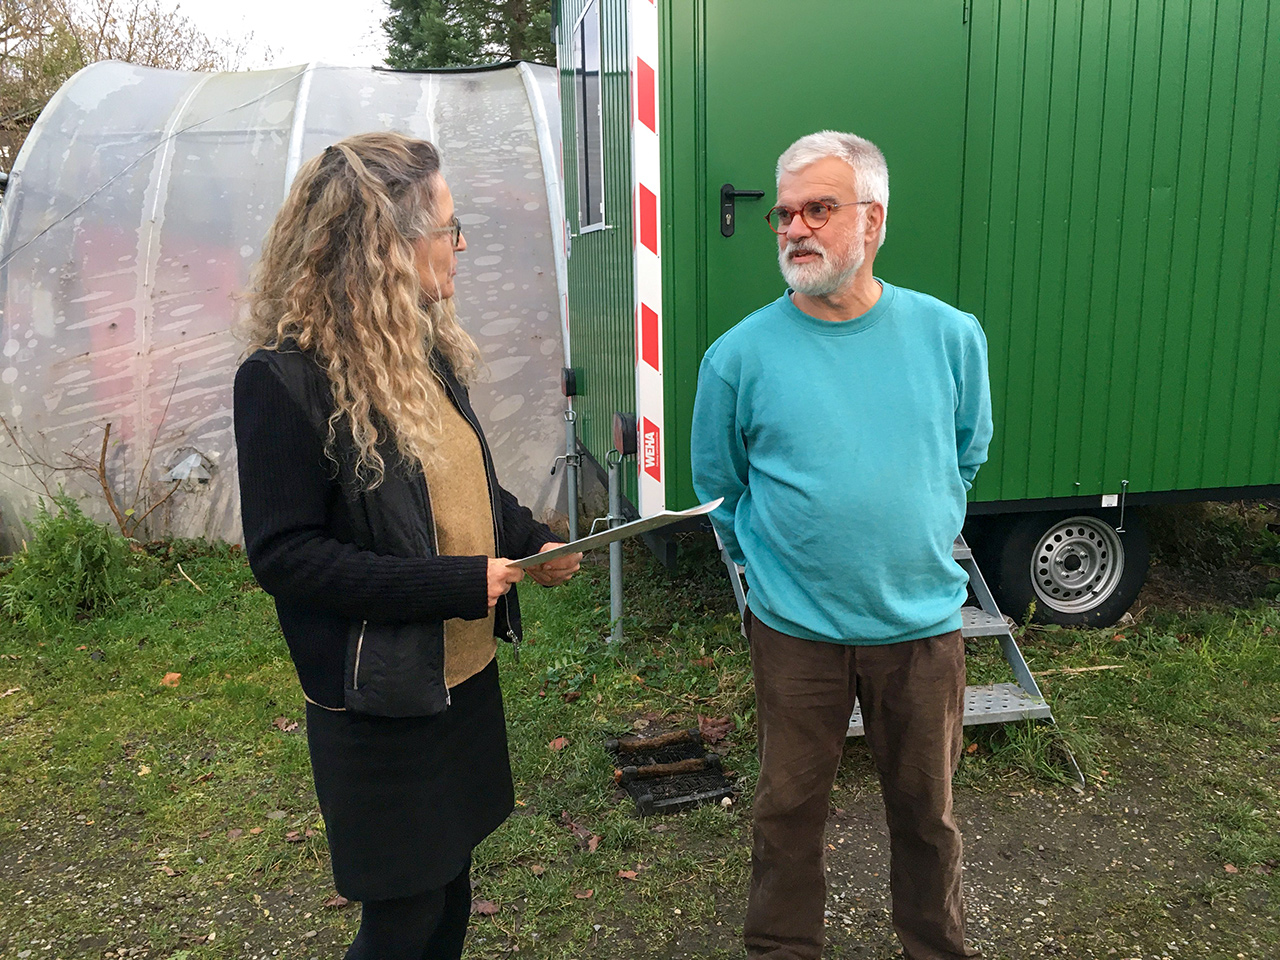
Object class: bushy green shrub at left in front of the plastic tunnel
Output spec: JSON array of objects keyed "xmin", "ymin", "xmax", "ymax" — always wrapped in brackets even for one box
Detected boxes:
[{"xmin": 0, "ymin": 494, "xmax": 134, "ymax": 630}]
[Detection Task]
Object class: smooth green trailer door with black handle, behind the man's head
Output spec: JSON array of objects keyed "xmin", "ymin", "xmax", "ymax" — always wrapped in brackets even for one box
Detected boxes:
[{"xmin": 703, "ymin": 0, "xmax": 968, "ymax": 344}]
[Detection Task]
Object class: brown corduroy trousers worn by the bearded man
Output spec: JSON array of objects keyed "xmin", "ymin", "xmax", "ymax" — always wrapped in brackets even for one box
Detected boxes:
[{"xmin": 742, "ymin": 611, "xmax": 979, "ymax": 960}]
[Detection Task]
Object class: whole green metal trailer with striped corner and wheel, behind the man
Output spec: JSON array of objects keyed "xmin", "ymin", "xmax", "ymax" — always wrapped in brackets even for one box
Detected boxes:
[{"xmin": 556, "ymin": 0, "xmax": 1280, "ymax": 623}]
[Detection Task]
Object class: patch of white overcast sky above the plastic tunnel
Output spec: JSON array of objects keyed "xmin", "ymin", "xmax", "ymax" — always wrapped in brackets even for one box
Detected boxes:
[{"xmin": 172, "ymin": 0, "xmax": 387, "ymax": 69}]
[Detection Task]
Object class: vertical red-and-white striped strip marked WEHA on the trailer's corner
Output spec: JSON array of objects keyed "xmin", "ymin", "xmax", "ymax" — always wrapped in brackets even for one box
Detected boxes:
[{"xmin": 630, "ymin": 0, "xmax": 667, "ymax": 517}]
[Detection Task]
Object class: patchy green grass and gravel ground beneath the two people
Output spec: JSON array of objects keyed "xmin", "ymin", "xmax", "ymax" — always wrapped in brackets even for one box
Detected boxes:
[{"xmin": 0, "ymin": 506, "xmax": 1280, "ymax": 960}]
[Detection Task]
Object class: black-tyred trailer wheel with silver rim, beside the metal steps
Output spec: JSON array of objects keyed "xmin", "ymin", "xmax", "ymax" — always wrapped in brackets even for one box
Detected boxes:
[{"xmin": 979, "ymin": 511, "xmax": 1148, "ymax": 627}]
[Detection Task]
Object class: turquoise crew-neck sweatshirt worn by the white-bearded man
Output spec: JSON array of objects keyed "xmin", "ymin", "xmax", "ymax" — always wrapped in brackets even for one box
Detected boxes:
[{"xmin": 692, "ymin": 283, "xmax": 991, "ymax": 644}]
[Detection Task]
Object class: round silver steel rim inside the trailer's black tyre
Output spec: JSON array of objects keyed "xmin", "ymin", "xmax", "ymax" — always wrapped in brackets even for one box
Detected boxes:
[{"xmin": 1032, "ymin": 517, "xmax": 1124, "ymax": 613}]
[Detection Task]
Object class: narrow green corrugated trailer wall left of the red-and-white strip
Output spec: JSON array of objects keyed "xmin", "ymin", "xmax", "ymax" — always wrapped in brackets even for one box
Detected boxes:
[{"xmin": 558, "ymin": 0, "xmax": 636, "ymax": 503}]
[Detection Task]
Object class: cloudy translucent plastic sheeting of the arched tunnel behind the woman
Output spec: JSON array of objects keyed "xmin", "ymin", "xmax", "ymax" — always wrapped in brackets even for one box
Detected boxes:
[{"xmin": 0, "ymin": 63, "xmax": 566, "ymax": 549}]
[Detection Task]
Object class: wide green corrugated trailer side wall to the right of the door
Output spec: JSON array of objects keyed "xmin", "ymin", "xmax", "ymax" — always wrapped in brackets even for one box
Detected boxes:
[{"xmin": 960, "ymin": 0, "xmax": 1280, "ymax": 500}]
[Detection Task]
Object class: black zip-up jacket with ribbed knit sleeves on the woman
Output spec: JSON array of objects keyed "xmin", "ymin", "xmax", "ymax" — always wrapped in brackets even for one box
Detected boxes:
[{"xmin": 236, "ymin": 348, "xmax": 554, "ymax": 717}]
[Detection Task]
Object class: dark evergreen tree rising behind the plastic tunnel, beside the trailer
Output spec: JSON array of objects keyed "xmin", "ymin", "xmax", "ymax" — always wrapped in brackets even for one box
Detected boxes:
[{"xmin": 383, "ymin": 0, "xmax": 556, "ymax": 70}]
